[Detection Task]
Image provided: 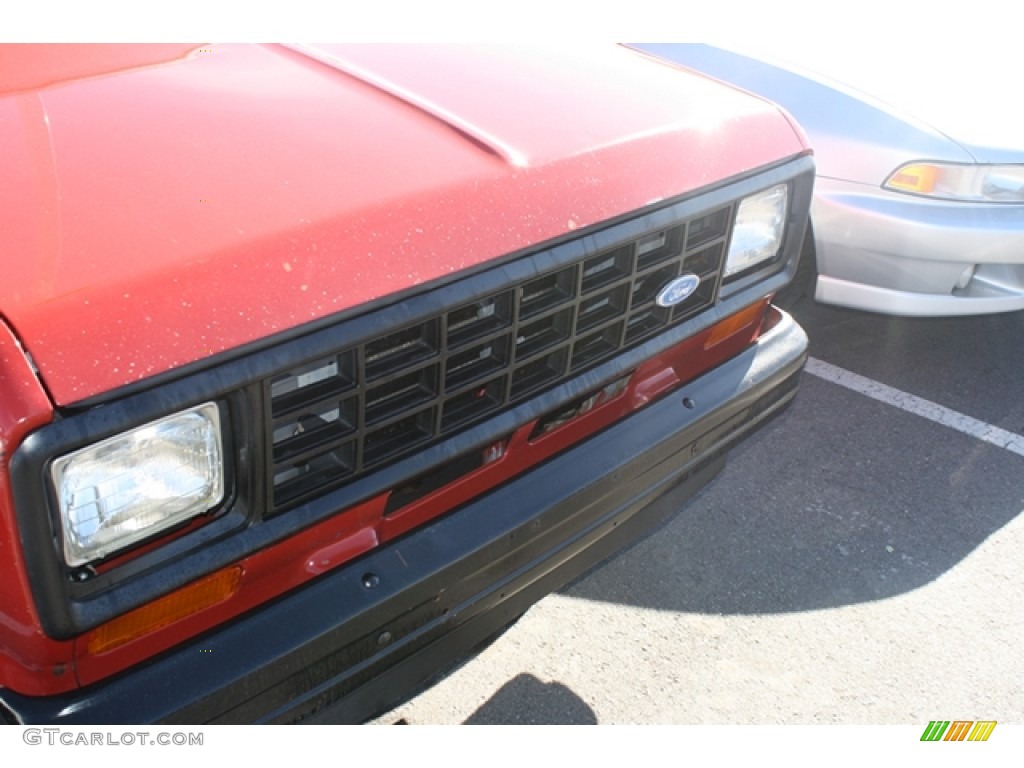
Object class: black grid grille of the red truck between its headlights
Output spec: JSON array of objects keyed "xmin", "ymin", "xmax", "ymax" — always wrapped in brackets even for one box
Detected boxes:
[{"xmin": 264, "ymin": 206, "xmax": 732, "ymax": 511}]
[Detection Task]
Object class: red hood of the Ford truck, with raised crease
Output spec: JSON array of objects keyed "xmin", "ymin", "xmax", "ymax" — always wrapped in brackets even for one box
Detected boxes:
[{"xmin": 0, "ymin": 45, "xmax": 806, "ymax": 404}]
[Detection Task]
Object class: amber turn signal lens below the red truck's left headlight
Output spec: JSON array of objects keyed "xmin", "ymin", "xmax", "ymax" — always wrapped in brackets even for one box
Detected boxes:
[{"xmin": 86, "ymin": 565, "xmax": 242, "ymax": 655}]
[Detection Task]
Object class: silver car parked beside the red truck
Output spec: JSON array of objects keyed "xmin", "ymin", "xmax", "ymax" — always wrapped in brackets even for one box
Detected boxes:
[{"xmin": 634, "ymin": 44, "xmax": 1024, "ymax": 315}]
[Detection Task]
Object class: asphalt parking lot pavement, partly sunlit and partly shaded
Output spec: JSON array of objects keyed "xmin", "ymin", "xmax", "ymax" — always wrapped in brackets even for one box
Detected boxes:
[{"xmin": 368, "ymin": 301, "xmax": 1024, "ymax": 727}]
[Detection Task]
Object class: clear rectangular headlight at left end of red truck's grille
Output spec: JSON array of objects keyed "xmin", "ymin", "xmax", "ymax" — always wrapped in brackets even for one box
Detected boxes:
[{"xmin": 50, "ymin": 402, "xmax": 224, "ymax": 566}]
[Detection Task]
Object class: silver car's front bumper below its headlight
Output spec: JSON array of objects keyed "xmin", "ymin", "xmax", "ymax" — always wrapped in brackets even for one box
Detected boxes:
[{"xmin": 811, "ymin": 177, "xmax": 1024, "ymax": 316}]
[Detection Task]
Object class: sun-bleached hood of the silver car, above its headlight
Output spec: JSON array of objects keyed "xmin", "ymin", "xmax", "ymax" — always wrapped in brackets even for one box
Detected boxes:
[{"xmin": 743, "ymin": 42, "xmax": 1024, "ymax": 163}]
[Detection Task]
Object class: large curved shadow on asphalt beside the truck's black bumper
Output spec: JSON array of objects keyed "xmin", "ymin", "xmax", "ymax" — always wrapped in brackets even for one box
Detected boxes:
[{"xmin": 564, "ymin": 308, "xmax": 1024, "ymax": 614}]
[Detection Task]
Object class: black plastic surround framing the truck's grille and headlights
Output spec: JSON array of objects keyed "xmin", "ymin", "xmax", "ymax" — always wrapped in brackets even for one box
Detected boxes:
[{"xmin": 11, "ymin": 155, "xmax": 814, "ymax": 639}]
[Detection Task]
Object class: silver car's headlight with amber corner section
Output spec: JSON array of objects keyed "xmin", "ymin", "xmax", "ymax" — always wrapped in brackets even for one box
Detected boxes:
[{"xmin": 883, "ymin": 163, "xmax": 1024, "ymax": 203}]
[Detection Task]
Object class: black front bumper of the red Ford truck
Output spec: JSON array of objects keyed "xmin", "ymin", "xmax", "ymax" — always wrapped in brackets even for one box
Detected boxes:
[{"xmin": 0, "ymin": 310, "xmax": 807, "ymax": 724}]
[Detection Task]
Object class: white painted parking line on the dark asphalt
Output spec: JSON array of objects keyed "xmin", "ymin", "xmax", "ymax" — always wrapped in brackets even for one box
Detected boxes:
[{"xmin": 805, "ymin": 357, "xmax": 1024, "ymax": 456}]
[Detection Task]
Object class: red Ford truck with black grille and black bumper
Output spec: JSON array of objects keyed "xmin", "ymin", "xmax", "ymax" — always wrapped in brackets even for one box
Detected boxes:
[{"xmin": 0, "ymin": 45, "xmax": 813, "ymax": 723}]
